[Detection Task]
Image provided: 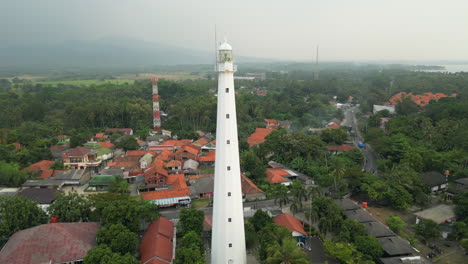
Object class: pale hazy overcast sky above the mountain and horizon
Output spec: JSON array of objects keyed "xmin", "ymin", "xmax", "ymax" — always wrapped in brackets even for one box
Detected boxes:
[{"xmin": 0, "ymin": 0, "xmax": 468, "ymax": 60}]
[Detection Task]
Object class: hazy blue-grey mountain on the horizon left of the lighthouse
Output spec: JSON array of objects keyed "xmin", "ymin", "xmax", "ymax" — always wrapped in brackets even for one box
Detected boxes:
[{"xmin": 0, "ymin": 38, "xmax": 218, "ymax": 67}]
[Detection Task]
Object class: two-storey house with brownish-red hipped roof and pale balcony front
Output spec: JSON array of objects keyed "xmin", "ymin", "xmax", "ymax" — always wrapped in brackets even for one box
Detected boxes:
[{"xmin": 63, "ymin": 146, "xmax": 102, "ymax": 170}]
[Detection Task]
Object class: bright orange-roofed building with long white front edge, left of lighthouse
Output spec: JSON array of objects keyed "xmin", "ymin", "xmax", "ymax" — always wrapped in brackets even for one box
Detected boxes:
[{"xmin": 141, "ymin": 174, "xmax": 192, "ymax": 207}]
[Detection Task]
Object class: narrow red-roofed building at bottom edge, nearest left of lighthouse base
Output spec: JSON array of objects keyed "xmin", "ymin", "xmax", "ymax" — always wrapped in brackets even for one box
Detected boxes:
[{"xmin": 140, "ymin": 217, "xmax": 176, "ymax": 264}]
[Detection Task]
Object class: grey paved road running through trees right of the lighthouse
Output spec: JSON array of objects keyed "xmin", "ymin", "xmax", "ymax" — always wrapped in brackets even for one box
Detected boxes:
[{"xmin": 342, "ymin": 107, "xmax": 378, "ymax": 173}]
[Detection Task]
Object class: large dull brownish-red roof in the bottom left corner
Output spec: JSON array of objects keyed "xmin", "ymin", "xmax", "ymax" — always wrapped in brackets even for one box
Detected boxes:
[{"xmin": 0, "ymin": 222, "xmax": 99, "ymax": 264}]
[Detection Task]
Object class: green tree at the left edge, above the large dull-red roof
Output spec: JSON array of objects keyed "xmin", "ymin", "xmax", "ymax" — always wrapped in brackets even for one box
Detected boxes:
[{"xmin": 0, "ymin": 196, "xmax": 47, "ymax": 245}]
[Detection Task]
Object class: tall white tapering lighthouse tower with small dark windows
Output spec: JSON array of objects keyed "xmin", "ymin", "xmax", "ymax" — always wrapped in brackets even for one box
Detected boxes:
[{"xmin": 211, "ymin": 40, "xmax": 246, "ymax": 264}]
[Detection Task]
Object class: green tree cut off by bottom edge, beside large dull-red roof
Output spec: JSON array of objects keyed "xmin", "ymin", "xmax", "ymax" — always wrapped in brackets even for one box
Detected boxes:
[{"xmin": 83, "ymin": 244, "xmax": 138, "ymax": 264}]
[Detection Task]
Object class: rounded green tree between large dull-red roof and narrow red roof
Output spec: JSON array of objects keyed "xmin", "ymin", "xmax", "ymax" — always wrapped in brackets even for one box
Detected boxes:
[{"xmin": 96, "ymin": 223, "xmax": 138, "ymax": 255}]
